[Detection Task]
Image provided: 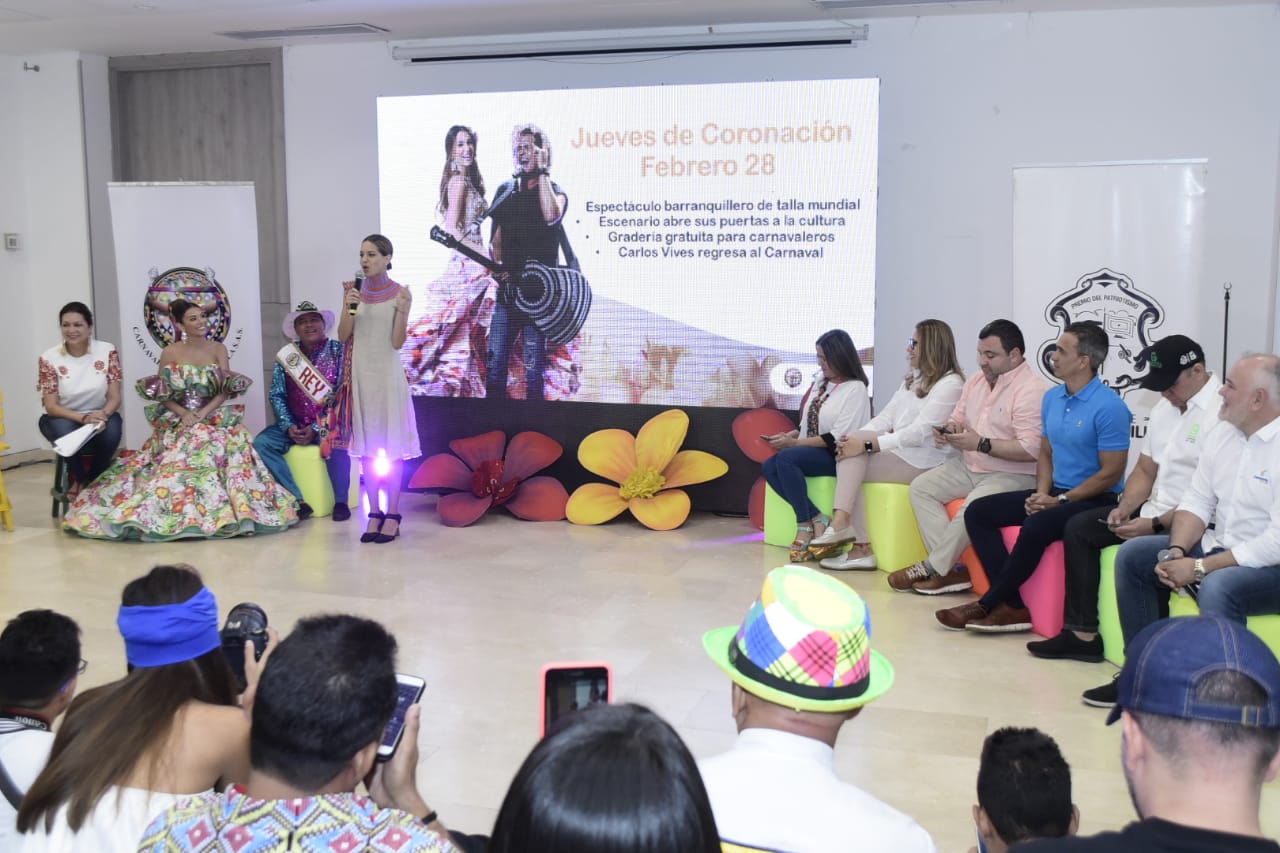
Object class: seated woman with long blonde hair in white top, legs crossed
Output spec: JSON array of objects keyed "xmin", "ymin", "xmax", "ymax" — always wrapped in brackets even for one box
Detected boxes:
[{"xmin": 813, "ymin": 320, "xmax": 964, "ymax": 570}]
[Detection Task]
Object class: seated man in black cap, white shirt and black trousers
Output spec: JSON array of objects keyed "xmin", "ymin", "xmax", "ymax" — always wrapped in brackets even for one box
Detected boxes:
[{"xmin": 1027, "ymin": 334, "xmax": 1222, "ymax": 662}]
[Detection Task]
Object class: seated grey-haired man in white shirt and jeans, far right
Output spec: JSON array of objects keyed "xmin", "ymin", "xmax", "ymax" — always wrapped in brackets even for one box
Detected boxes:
[{"xmin": 1084, "ymin": 355, "xmax": 1280, "ymax": 707}]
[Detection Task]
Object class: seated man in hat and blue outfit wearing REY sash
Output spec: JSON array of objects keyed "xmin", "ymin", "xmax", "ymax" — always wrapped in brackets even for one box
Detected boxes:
[{"xmin": 253, "ymin": 302, "xmax": 351, "ymax": 521}]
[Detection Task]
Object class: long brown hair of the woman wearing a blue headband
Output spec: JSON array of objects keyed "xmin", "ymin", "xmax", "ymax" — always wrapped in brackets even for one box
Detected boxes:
[{"xmin": 18, "ymin": 565, "xmax": 236, "ymax": 833}]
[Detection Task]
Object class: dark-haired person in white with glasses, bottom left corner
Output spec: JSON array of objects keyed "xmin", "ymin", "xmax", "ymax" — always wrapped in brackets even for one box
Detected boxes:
[{"xmin": 0, "ymin": 610, "xmax": 84, "ymax": 850}]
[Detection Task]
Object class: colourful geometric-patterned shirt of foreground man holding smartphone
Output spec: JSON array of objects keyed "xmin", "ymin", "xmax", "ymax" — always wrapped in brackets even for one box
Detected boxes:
[{"xmin": 138, "ymin": 785, "xmax": 457, "ymax": 853}]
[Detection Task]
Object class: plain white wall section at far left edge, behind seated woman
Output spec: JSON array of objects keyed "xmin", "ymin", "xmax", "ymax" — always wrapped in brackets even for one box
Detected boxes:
[{"xmin": 0, "ymin": 53, "xmax": 92, "ymax": 451}]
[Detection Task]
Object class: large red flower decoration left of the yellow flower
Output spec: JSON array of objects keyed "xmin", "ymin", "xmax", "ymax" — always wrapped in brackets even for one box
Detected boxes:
[{"xmin": 408, "ymin": 429, "xmax": 568, "ymax": 528}]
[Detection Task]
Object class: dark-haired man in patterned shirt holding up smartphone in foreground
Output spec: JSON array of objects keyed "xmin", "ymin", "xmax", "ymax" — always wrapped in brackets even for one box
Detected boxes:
[{"xmin": 138, "ymin": 616, "xmax": 456, "ymax": 853}]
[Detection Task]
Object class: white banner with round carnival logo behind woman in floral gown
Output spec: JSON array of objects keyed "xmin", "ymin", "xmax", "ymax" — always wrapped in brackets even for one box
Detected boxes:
[{"xmin": 108, "ymin": 183, "xmax": 268, "ymax": 448}]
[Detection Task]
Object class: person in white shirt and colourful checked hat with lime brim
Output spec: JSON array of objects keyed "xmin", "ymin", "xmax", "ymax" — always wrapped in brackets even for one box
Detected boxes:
[{"xmin": 699, "ymin": 566, "xmax": 937, "ymax": 853}]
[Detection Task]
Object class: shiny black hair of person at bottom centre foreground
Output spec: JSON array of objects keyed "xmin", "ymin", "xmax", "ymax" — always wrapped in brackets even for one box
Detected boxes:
[{"xmin": 489, "ymin": 704, "xmax": 721, "ymax": 853}]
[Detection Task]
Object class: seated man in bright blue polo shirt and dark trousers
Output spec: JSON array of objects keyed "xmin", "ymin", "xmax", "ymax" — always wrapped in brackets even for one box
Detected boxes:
[{"xmin": 934, "ymin": 323, "xmax": 1133, "ymax": 633}]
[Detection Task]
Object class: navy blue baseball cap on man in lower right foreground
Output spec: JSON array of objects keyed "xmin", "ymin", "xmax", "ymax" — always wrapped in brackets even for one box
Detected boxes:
[{"xmin": 1107, "ymin": 616, "xmax": 1280, "ymax": 729}]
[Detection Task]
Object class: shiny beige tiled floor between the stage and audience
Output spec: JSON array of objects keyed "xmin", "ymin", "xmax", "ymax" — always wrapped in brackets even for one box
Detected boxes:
[{"xmin": 0, "ymin": 464, "xmax": 1280, "ymax": 850}]
